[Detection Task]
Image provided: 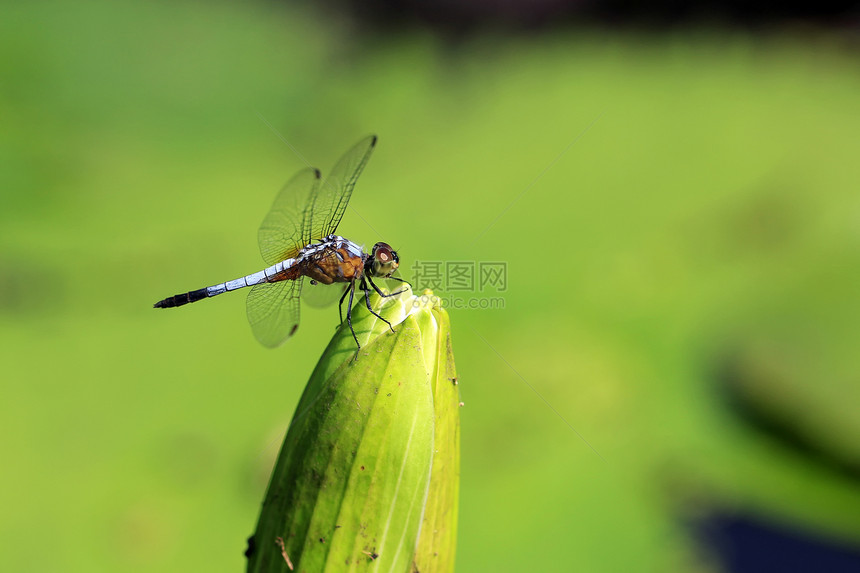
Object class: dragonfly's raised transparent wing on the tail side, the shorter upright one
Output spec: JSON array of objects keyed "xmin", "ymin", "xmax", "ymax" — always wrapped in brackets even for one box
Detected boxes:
[{"xmin": 257, "ymin": 168, "xmax": 320, "ymax": 265}]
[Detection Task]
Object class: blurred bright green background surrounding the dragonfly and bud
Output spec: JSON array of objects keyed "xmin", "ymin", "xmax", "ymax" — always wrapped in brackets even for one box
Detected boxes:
[{"xmin": 0, "ymin": 0, "xmax": 860, "ymax": 571}]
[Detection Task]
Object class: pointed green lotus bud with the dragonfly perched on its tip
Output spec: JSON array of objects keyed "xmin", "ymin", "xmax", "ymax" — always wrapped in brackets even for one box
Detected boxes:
[{"xmin": 242, "ymin": 284, "xmax": 459, "ymax": 573}]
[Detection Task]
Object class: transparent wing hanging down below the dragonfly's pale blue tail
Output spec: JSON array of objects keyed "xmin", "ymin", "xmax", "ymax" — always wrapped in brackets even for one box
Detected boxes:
[{"xmin": 247, "ymin": 277, "xmax": 302, "ymax": 348}]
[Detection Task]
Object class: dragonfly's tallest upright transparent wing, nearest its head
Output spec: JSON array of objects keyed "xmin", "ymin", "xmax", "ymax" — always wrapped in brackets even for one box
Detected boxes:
[{"xmin": 310, "ymin": 135, "xmax": 376, "ymax": 239}]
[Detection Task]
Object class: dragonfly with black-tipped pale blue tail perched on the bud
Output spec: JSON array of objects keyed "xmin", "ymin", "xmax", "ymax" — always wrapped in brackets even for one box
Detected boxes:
[{"xmin": 154, "ymin": 135, "xmax": 409, "ymax": 349}]
